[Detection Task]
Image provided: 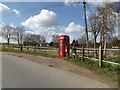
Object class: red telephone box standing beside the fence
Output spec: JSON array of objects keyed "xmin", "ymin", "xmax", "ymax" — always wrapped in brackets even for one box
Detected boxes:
[{"xmin": 58, "ymin": 35, "xmax": 70, "ymax": 57}]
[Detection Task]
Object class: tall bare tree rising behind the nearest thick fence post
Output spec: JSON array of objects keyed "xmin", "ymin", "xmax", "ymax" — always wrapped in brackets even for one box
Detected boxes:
[{"xmin": 98, "ymin": 3, "xmax": 116, "ymax": 54}]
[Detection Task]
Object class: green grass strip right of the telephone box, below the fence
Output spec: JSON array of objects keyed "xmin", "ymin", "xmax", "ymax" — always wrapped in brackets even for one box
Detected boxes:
[{"xmin": 64, "ymin": 58, "xmax": 120, "ymax": 85}]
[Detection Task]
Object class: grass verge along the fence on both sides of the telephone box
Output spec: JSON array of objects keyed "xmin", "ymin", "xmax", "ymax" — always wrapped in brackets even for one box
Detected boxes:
[{"xmin": 0, "ymin": 48, "xmax": 120, "ymax": 84}]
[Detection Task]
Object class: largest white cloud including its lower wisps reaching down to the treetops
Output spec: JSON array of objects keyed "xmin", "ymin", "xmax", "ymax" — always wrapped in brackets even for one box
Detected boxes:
[{"xmin": 21, "ymin": 9, "xmax": 59, "ymax": 41}]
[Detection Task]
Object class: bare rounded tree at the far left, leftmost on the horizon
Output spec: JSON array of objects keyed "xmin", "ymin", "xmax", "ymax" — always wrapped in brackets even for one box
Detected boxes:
[{"xmin": 1, "ymin": 25, "xmax": 14, "ymax": 45}]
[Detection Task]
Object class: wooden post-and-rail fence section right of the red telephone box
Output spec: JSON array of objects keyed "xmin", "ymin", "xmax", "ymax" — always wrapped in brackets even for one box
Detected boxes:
[{"xmin": 77, "ymin": 47, "xmax": 120, "ymax": 67}]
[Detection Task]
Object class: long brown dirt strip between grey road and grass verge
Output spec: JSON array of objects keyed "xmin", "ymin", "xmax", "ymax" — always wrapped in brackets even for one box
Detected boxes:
[{"xmin": 2, "ymin": 52, "xmax": 117, "ymax": 88}]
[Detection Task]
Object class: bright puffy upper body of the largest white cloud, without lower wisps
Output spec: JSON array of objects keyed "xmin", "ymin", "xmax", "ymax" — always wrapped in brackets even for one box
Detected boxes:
[{"xmin": 22, "ymin": 9, "xmax": 58, "ymax": 29}]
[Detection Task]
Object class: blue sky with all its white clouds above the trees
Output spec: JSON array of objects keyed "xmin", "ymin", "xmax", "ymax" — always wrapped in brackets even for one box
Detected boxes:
[{"xmin": 0, "ymin": 0, "xmax": 119, "ymax": 42}]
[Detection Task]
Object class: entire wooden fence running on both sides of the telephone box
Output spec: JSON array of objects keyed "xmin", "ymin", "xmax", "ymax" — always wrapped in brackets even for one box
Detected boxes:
[{"xmin": 2, "ymin": 45, "xmax": 120, "ymax": 67}]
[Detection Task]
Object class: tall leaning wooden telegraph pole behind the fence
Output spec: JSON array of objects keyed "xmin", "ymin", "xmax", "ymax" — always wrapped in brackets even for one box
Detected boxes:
[{"xmin": 83, "ymin": 0, "xmax": 89, "ymax": 55}]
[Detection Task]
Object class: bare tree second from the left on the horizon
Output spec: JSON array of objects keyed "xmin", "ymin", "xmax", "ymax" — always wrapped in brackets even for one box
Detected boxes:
[{"xmin": 14, "ymin": 27, "xmax": 25, "ymax": 44}]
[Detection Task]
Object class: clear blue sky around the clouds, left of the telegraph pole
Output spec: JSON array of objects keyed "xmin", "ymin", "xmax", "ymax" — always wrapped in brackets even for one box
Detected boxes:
[{"xmin": 2, "ymin": 2, "xmax": 84, "ymax": 26}]
